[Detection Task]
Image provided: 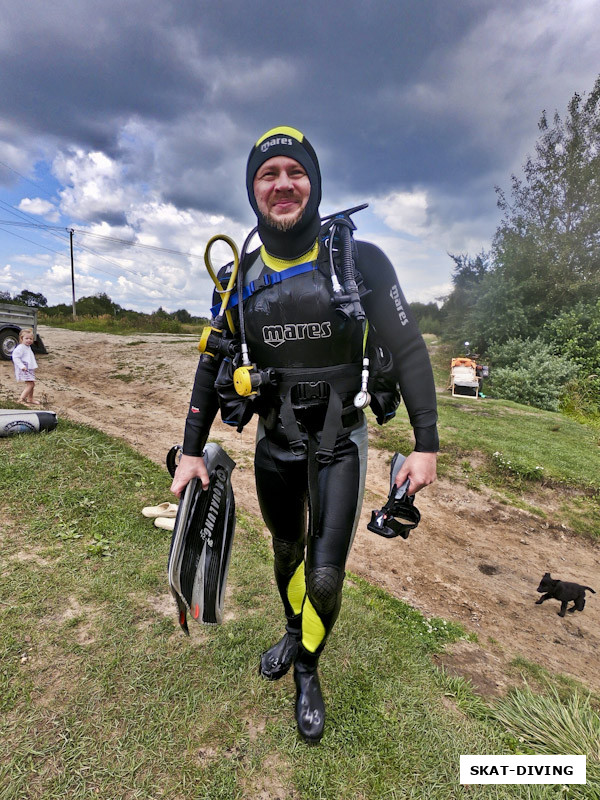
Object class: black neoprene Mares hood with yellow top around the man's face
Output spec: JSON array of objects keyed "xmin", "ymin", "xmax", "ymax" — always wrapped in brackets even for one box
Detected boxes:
[{"xmin": 246, "ymin": 126, "xmax": 321, "ymax": 259}]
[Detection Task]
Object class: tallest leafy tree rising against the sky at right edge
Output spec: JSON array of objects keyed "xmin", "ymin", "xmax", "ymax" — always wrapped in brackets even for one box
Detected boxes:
[{"xmin": 493, "ymin": 76, "xmax": 600, "ymax": 328}]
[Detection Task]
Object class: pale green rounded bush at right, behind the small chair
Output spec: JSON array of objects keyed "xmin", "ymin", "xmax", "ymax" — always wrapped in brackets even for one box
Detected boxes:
[{"xmin": 487, "ymin": 338, "xmax": 578, "ymax": 411}]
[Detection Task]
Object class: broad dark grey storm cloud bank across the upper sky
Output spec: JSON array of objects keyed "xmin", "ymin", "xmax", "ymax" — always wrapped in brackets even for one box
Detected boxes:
[{"xmin": 0, "ymin": 0, "xmax": 594, "ymax": 234}]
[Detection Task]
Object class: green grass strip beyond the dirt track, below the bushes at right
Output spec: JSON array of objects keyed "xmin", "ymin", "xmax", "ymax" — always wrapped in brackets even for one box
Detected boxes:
[{"xmin": 371, "ymin": 372, "xmax": 600, "ymax": 537}]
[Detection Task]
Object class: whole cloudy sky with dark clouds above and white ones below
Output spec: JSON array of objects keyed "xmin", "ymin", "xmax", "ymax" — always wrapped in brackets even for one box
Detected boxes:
[{"xmin": 0, "ymin": 0, "xmax": 600, "ymax": 316}]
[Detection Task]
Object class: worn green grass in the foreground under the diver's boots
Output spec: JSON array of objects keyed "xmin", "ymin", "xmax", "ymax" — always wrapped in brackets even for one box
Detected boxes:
[{"xmin": 0, "ymin": 421, "xmax": 592, "ymax": 800}]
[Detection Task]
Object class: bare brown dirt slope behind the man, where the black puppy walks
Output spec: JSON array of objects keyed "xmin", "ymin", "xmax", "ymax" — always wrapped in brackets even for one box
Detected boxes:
[{"xmin": 0, "ymin": 328, "xmax": 600, "ymax": 694}]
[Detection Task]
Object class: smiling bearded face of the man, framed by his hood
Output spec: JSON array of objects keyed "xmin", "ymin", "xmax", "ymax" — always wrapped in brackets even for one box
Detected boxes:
[{"xmin": 253, "ymin": 156, "xmax": 310, "ymax": 231}]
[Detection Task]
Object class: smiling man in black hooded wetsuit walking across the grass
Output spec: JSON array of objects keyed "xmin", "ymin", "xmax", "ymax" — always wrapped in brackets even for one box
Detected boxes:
[{"xmin": 171, "ymin": 127, "xmax": 438, "ymax": 742}]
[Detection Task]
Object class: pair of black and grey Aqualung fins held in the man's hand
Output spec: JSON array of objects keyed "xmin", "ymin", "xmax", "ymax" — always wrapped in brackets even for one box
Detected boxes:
[{"xmin": 167, "ymin": 442, "xmax": 235, "ymax": 634}]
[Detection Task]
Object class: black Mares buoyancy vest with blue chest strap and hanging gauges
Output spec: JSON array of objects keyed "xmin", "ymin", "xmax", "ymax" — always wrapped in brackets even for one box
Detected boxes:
[{"xmin": 206, "ymin": 206, "xmax": 400, "ymax": 446}]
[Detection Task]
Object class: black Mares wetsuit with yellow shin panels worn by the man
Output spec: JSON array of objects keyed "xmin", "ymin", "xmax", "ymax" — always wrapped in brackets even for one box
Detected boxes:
[{"xmin": 183, "ymin": 236, "xmax": 438, "ymax": 663}]
